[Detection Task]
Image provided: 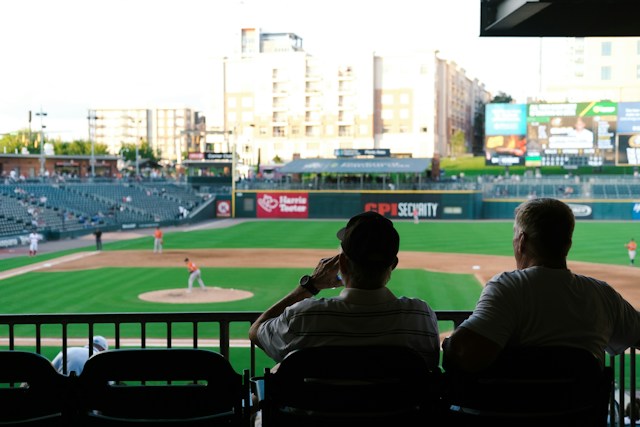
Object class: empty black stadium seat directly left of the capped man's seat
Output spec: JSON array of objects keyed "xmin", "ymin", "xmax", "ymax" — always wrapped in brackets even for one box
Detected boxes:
[{"xmin": 77, "ymin": 348, "xmax": 249, "ymax": 426}]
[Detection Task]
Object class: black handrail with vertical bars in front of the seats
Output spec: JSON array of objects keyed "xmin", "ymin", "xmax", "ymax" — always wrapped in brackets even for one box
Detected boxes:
[{"xmin": 0, "ymin": 310, "xmax": 636, "ymax": 426}]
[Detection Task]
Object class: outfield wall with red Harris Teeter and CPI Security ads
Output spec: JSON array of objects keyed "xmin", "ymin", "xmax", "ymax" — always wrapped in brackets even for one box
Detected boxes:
[{"xmin": 234, "ymin": 190, "xmax": 640, "ymax": 221}]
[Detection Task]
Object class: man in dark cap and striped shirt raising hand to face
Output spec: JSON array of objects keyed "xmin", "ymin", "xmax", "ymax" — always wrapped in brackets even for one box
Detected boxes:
[{"xmin": 249, "ymin": 212, "xmax": 440, "ymax": 368}]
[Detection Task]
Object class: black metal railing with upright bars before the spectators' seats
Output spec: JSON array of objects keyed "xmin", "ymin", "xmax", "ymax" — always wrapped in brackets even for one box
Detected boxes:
[{"xmin": 0, "ymin": 311, "xmax": 636, "ymax": 426}]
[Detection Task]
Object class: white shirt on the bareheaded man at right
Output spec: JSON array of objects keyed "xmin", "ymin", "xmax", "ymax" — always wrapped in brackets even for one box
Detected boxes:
[{"xmin": 461, "ymin": 267, "xmax": 640, "ymax": 363}]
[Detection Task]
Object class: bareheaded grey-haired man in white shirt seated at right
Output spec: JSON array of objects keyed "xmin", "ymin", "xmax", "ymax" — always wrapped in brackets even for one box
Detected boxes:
[{"xmin": 443, "ymin": 198, "xmax": 640, "ymax": 372}]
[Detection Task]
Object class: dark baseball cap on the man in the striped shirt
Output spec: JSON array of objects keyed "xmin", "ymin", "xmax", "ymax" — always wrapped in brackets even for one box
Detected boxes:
[{"xmin": 337, "ymin": 211, "xmax": 400, "ymax": 269}]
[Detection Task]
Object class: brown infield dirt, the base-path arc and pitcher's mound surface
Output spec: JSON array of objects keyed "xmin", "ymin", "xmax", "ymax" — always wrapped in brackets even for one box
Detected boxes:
[{"xmin": 41, "ymin": 249, "xmax": 640, "ymax": 309}]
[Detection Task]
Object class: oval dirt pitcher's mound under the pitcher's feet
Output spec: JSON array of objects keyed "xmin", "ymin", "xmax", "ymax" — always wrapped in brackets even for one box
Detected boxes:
[{"xmin": 138, "ymin": 287, "xmax": 253, "ymax": 304}]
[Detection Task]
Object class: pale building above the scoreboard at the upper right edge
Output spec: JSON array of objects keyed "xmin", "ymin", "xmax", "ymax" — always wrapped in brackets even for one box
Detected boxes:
[{"xmin": 541, "ymin": 37, "xmax": 640, "ymax": 102}]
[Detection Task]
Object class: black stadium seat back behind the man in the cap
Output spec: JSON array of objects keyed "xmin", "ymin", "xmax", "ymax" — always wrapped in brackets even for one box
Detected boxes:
[{"xmin": 261, "ymin": 346, "xmax": 440, "ymax": 427}]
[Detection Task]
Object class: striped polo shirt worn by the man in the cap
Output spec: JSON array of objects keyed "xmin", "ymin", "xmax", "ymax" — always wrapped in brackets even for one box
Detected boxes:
[{"xmin": 258, "ymin": 287, "xmax": 440, "ymax": 367}]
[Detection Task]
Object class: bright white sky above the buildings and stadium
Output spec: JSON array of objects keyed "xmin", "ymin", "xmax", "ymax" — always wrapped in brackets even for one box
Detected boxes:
[{"xmin": 0, "ymin": 0, "xmax": 540, "ymax": 140}]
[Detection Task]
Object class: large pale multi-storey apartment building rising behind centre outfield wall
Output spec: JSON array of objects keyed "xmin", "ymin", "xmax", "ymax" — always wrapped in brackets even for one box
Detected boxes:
[{"xmin": 217, "ymin": 28, "xmax": 489, "ymax": 165}]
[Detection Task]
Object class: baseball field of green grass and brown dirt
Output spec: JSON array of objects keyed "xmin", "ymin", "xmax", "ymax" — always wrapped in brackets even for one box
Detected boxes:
[{"xmin": 0, "ymin": 220, "xmax": 640, "ymax": 376}]
